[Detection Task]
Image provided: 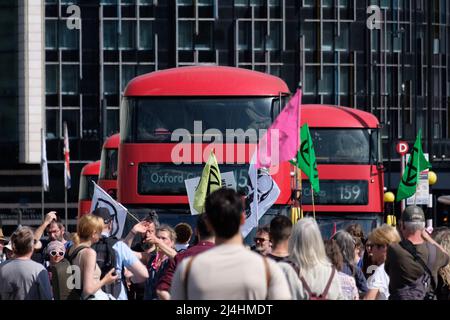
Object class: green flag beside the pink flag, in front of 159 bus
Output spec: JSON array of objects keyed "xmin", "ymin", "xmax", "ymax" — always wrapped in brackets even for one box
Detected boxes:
[{"xmin": 291, "ymin": 123, "xmax": 320, "ymax": 192}]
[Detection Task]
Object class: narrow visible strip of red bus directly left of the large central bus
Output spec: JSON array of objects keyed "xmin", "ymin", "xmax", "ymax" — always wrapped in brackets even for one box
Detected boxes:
[{"xmin": 98, "ymin": 133, "xmax": 120, "ymax": 199}]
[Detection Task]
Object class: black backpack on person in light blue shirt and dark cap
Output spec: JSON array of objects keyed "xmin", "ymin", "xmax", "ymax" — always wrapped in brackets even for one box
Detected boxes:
[{"xmin": 91, "ymin": 236, "xmax": 125, "ymax": 298}]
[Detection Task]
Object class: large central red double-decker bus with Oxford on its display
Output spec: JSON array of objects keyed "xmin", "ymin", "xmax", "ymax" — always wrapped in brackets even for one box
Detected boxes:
[{"xmin": 118, "ymin": 66, "xmax": 290, "ymax": 228}]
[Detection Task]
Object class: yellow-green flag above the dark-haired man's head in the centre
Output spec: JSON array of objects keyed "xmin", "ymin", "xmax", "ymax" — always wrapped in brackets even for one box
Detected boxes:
[{"xmin": 194, "ymin": 150, "xmax": 222, "ymax": 213}]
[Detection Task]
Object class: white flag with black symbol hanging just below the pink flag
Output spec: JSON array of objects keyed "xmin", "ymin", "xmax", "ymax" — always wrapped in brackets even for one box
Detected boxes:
[{"xmin": 241, "ymin": 152, "xmax": 280, "ymax": 238}]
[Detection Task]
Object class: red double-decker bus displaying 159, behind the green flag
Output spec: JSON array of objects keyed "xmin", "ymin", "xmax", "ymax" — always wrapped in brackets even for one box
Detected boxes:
[{"xmin": 301, "ymin": 105, "xmax": 384, "ymax": 236}]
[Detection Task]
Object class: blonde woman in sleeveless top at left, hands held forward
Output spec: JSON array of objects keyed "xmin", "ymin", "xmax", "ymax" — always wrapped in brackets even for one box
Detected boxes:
[{"xmin": 69, "ymin": 214, "xmax": 119, "ymax": 300}]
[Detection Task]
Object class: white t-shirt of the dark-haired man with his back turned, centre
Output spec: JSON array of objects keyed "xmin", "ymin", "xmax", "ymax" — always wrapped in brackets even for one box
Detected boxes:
[{"xmin": 171, "ymin": 244, "xmax": 291, "ymax": 300}]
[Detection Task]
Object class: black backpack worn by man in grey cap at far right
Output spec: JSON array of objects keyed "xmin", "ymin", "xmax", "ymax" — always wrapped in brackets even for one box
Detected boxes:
[{"xmin": 389, "ymin": 240, "xmax": 436, "ymax": 300}]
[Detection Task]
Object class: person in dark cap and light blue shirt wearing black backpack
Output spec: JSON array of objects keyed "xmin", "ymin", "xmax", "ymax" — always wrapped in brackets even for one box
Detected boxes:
[{"xmin": 92, "ymin": 208, "xmax": 148, "ymax": 300}]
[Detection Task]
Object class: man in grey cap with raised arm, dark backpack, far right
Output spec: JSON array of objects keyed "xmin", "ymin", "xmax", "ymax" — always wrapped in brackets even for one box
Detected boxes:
[{"xmin": 384, "ymin": 206, "xmax": 449, "ymax": 300}]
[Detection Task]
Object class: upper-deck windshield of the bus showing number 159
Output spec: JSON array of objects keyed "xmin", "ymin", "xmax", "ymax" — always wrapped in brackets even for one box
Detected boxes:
[{"xmin": 311, "ymin": 128, "xmax": 379, "ymax": 164}]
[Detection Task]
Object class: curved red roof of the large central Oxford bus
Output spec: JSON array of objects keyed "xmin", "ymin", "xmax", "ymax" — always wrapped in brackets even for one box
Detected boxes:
[{"xmin": 124, "ymin": 66, "xmax": 289, "ymax": 96}]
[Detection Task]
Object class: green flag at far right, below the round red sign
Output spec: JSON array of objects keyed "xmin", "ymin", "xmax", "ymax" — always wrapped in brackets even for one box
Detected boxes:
[{"xmin": 396, "ymin": 129, "xmax": 431, "ymax": 201}]
